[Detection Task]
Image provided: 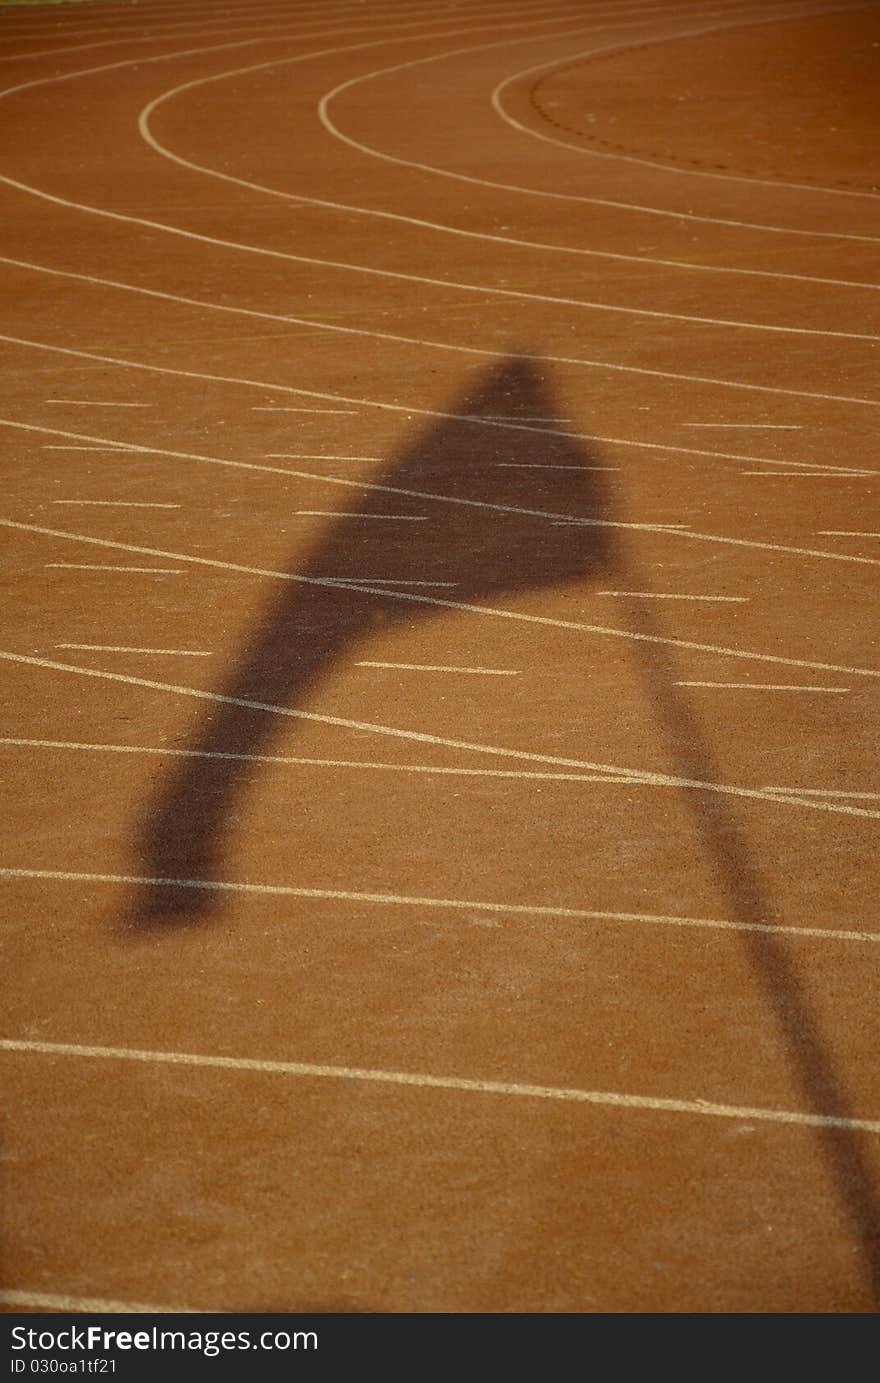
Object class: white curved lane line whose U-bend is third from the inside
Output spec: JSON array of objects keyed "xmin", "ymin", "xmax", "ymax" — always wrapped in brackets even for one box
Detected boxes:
[{"xmin": 137, "ymin": 45, "xmax": 880, "ymax": 294}]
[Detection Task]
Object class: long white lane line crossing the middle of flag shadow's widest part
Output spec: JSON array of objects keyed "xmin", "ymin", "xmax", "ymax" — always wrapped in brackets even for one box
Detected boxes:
[{"xmin": 6, "ymin": 403, "xmax": 880, "ymax": 566}]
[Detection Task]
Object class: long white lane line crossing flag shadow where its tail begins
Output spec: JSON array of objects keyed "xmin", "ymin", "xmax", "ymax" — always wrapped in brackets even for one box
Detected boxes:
[{"xmin": 0, "ymin": 519, "xmax": 880, "ymax": 691}]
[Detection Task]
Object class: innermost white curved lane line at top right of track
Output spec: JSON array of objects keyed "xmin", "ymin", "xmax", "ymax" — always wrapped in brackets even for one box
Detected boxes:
[{"xmin": 491, "ymin": 4, "xmax": 880, "ymax": 199}]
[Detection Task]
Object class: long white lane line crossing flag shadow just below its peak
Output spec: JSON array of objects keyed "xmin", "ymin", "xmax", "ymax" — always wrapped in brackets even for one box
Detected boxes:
[{"xmin": 0, "ymin": 320, "xmax": 877, "ymax": 495}]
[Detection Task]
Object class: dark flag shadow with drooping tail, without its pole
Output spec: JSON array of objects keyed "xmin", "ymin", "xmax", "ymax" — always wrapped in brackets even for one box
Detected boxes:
[{"xmin": 136, "ymin": 358, "xmax": 613, "ymax": 922}]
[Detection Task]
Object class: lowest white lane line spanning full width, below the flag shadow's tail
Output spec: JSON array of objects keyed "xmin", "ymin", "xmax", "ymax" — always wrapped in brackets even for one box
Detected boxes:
[{"xmin": 6, "ymin": 1037, "xmax": 880, "ymax": 1134}]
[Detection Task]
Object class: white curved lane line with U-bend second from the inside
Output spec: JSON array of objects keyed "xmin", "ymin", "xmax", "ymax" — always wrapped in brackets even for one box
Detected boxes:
[{"xmin": 316, "ymin": 11, "xmax": 877, "ymax": 248}]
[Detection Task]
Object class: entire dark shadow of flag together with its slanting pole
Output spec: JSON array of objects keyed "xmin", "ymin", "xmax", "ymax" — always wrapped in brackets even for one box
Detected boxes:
[{"xmin": 130, "ymin": 358, "xmax": 880, "ymax": 1300}]
